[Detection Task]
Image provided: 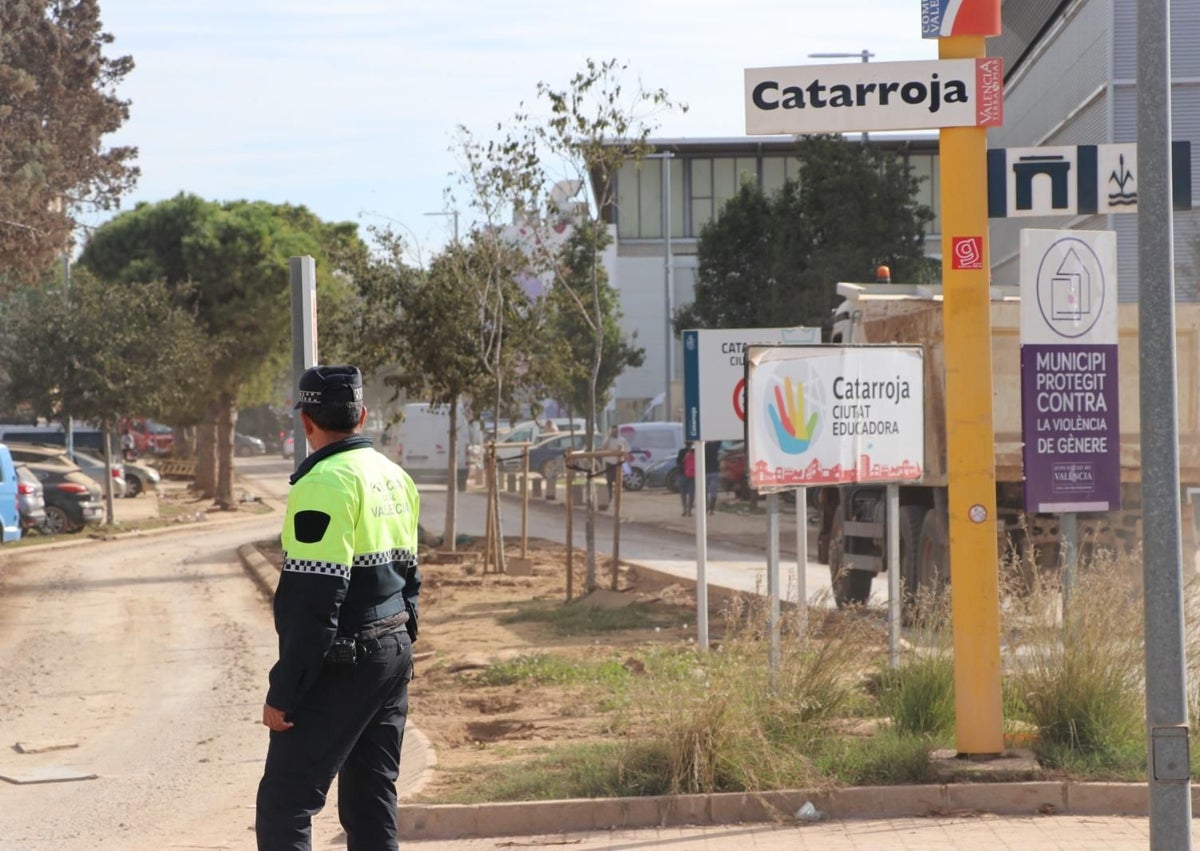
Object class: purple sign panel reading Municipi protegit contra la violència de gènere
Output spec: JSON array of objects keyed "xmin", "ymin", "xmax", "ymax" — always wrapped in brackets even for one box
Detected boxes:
[{"xmin": 1021, "ymin": 343, "xmax": 1121, "ymax": 514}]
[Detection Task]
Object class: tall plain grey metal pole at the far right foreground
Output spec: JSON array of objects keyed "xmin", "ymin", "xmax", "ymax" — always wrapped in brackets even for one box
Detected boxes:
[{"xmin": 1138, "ymin": 0, "xmax": 1192, "ymax": 851}]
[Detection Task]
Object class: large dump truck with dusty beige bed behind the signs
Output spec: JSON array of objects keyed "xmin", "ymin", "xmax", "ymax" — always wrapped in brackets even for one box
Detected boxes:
[{"xmin": 816, "ymin": 283, "xmax": 1200, "ymax": 605}]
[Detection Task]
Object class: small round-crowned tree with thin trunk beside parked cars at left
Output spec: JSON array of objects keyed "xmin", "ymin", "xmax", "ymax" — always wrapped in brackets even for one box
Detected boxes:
[{"xmin": 0, "ymin": 271, "xmax": 206, "ymax": 523}]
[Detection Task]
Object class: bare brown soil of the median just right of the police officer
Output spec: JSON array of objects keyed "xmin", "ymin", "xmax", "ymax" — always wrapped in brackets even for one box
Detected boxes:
[{"xmin": 260, "ymin": 539, "xmax": 724, "ymax": 802}]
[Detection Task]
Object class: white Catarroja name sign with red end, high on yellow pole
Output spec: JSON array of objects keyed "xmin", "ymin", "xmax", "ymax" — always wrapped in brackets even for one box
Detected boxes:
[{"xmin": 745, "ymin": 58, "xmax": 1004, "ymax": 136}]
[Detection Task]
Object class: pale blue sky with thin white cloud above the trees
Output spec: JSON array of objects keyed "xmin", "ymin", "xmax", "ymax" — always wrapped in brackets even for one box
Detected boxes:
[{"xmin": 92, "ymin": 0, "xmax": 937, "ymax": 259}]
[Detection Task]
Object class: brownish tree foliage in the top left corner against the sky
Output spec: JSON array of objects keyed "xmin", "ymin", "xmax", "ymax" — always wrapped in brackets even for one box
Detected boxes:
[{"xmin": 0, "ymin": 0, "xmax": 138, "ymax": 289}]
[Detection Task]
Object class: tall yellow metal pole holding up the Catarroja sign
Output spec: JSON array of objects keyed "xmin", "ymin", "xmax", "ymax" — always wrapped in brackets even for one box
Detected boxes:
[{"xmin": 938, "ymin": 36, "xmax": 1004, "ymax": 756}]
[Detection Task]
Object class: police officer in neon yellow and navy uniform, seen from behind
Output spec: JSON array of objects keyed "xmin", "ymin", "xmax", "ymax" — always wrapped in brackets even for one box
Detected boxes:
[{"xmin": 254, "ymin": 366, "xmax": 421, "ymax": 851}]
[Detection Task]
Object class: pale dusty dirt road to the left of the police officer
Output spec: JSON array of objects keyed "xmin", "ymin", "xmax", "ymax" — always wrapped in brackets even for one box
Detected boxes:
[{"xmin": 0, "ymin": 514, "xmax": 326, "ymax": 851}]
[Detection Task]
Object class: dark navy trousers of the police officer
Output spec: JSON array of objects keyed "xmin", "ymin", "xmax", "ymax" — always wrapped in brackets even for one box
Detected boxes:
[{"xmin": 254, "ymin": 629, "xmax": 413, "ymax": 851}]
